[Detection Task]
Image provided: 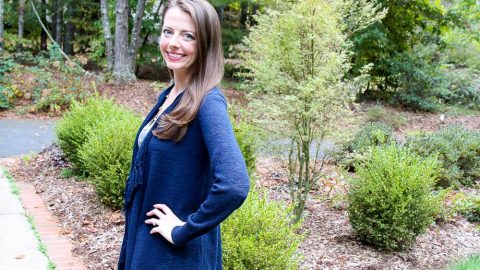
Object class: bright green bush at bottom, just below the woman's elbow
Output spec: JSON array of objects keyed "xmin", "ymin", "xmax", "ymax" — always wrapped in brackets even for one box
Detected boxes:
[{"xmin": 222, "ymin": 188, "xmax": 303, "ymax": 270}]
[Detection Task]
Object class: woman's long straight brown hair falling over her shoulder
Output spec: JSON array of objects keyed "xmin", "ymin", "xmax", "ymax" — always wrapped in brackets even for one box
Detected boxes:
[{"xmin": 153, "ymin": 0, "xmax": 224, "ymax": 142}]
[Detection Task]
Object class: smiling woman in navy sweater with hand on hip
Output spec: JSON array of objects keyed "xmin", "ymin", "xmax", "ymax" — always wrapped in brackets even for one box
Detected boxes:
[{"xmin": 118, "ymin": 0, "xmax": 249, "ymax": 270}]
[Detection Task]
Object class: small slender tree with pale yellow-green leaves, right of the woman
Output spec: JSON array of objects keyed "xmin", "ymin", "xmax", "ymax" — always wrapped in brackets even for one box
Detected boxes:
[{"xmin": 243, "ymin": 0, "xmax": 384, "ymax": 219}]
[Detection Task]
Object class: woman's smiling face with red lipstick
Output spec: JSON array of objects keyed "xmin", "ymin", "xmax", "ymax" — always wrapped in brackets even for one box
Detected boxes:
[{"xmin": 160, "ymin": 7, "xmax": 198, "ymax": 74}]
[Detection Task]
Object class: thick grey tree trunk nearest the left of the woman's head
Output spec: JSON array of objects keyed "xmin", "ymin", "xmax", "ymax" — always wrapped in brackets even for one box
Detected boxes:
[{"xmin": 113, "ymin": 0, "xmax": 135, "ymax": 83}]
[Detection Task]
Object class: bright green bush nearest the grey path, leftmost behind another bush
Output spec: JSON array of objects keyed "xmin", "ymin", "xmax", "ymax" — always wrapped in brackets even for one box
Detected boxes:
[{"xmin": 55, "ymin": 95, "xmax": 123, "ymax": 173}]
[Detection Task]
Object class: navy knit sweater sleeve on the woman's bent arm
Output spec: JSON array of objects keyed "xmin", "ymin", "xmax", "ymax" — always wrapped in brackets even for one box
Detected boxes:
[{"xmin": 172, "ymin": 90, "xmax": 249, "ymax": 245}]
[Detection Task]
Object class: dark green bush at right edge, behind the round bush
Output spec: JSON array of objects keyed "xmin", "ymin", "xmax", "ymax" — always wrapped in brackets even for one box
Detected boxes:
[{"xmin": 405, "ymin": 125, "xmax": 480, "ymax": 187}]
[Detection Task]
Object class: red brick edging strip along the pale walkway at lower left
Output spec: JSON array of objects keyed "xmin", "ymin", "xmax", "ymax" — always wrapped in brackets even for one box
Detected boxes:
[{"xmin": 16, "ymin": 182, "xmax": 86, "ymax": 270}]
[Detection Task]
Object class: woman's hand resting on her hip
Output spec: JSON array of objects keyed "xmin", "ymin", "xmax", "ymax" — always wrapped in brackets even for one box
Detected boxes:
[{"xmin": 145, "ymin": 204, "xmax": 185, "ymax": 244}]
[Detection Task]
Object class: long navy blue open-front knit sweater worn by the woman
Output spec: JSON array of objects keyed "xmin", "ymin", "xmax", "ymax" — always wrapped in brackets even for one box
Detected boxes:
[{"xmin": 118, "ymin": 86, "xmax": 249, "ymax": 270}]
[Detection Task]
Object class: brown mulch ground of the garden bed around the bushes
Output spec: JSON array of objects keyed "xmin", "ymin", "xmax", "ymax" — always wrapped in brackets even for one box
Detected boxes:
[{"xmin": 0, "ymin": 81, "xmax": 480, "ymax": 270}]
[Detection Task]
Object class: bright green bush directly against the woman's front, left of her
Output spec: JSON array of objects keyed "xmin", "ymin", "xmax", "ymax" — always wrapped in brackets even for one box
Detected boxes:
[{"xmin": 78, "ymin": 111, "xmax": 141, "ymax": 209}]
